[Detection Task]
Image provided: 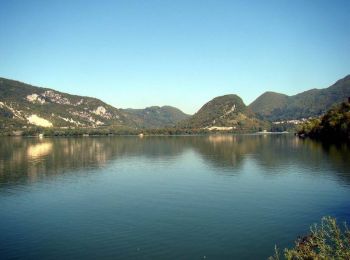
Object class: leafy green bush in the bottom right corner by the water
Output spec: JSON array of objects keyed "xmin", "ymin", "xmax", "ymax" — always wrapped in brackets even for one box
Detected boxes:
[{"xmin": 269, "ymin": 217, "xmax": 350, "ymax": 260}]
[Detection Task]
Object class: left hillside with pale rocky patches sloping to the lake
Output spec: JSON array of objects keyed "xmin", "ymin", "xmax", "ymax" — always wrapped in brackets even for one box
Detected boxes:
[{"xmin": 0, "ymin": 78, "xmax": 135, "ymax": 127}]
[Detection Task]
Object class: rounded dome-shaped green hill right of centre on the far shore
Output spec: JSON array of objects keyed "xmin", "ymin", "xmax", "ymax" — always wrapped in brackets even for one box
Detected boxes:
[{"xmin": 179, "ymin": 95, "xmax": 264, "ymax": 130}]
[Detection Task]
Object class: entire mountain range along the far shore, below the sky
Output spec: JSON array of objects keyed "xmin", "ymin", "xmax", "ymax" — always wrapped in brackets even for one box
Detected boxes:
[{"xmin": 0, "ymin": 75, "xmax": 350, "ymax": 131}]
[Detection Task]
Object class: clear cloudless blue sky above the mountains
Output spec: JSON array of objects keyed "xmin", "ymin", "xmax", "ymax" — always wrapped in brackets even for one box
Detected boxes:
[{"xmin": 0, "ymin": 0, "xmax": 350, "ymax": 113}]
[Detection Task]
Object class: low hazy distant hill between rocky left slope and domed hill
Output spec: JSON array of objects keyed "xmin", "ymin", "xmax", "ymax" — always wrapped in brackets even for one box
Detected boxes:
[{"xmin": 123, "ymin": 106, "xmax": 190, "ymax": 128}]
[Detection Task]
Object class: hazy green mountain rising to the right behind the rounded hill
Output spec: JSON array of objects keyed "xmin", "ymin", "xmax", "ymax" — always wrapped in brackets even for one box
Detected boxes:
[{"xmin": 249, "ymin": 75, "xmax": 350, "ymax": 121}]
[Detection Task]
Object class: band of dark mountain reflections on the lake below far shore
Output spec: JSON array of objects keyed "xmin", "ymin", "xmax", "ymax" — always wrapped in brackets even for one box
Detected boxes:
[{"xmin": 0, "ymin": 135, "xmax": 350, "ymax": 185}]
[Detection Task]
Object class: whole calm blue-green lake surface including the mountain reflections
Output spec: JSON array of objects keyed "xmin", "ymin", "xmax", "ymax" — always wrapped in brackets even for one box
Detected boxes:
[{"xmin": 0, "ymin": 135, "xmax": 350, "ymax": 259}]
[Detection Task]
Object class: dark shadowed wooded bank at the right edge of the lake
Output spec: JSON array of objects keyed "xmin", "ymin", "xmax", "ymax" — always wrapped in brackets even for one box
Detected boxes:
[{"xmin": 298, "ymin": 99, "xmax": 350, "ymax": 142}]
